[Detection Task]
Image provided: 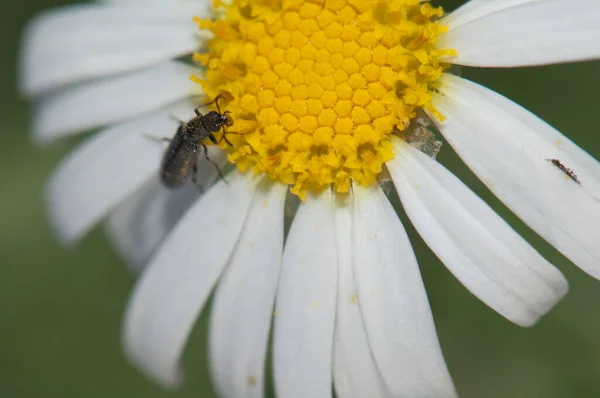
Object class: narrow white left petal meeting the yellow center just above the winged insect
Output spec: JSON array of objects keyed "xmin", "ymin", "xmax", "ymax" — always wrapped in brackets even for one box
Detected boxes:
[{"xmin": 34, "ymin": 62, "xmax": 200, "ymax": 142}]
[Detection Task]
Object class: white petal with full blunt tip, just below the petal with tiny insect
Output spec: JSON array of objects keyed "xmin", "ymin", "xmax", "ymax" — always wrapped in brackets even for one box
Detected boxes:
[{"xmin": 387, "ymin": 139, "xmax": 568, "ymax": 326}]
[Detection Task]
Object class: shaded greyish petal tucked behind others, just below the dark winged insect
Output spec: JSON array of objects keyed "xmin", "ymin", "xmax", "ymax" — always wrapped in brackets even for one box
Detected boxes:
[{"xmin": 107, "ymin": 146, "xmax": 227, "ymax": 272}]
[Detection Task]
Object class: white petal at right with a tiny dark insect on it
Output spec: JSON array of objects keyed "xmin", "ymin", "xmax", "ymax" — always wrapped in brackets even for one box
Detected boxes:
[{"xmin": 433, "ymin": 76, "xmax": 600, "ymax": 278}]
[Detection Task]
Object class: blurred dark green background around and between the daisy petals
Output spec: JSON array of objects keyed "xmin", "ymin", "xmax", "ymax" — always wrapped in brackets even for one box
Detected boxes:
[{"xmin": 0, "ymin": 0, "xmax": 600, "ymax": 398}]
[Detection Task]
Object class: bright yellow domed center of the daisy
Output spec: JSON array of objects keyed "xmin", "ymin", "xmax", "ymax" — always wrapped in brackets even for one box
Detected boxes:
[{"xmin": 192, "ymin": 0, "xmax": 453, "ymax": 199}]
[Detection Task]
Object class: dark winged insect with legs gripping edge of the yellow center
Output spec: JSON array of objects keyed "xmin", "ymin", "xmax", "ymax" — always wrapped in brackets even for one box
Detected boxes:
[{"xmin": 160, "ymin": 95, "xmax": 233, "ymax": 189}]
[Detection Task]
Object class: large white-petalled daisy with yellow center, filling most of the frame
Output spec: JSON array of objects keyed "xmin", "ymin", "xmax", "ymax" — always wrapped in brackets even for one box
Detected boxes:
[{"xmin": 21, "ymin": 0, "xmax": 600, "ymax": 397}]
